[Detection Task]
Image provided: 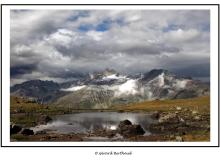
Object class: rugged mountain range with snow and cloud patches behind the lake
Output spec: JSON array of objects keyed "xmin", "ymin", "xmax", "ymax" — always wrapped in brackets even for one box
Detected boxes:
[{"xmin": 10, "ymin": 69, "xmax": 210, "ymax": 109}]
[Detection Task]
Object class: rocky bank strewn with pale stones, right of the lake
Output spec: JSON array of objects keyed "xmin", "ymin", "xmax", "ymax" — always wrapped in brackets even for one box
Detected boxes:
[{"xmin": 149, "ymin": 107, "xmax": 210, "ymax": 141}]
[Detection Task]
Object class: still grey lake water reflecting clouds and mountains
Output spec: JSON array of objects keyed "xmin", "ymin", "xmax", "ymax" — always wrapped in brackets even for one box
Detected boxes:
[{"xmin": 32, "ymin": 112, "xmax": 154, "ymax": 134}]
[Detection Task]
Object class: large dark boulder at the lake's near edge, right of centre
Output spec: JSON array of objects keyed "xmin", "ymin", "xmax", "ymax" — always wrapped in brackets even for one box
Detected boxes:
[{"xmin": 117, "ymin": 120, "xmax": 145, "ymax": 137}]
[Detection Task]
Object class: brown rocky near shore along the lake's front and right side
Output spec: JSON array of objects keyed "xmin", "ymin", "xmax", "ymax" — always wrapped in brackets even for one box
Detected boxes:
[{"xmin": 11, "ymin": 107, "xmax": 210, "ymax": 142}]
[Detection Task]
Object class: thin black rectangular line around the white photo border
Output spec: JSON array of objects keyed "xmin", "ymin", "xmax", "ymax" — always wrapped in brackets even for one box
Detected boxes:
[{"xmin": 1, "ymin": 4, "xmax": 220, "ymax": 148}]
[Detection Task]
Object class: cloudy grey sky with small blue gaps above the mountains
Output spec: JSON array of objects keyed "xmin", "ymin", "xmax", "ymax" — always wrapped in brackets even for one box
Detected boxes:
[{"xmin": 10, "ymin": 10, "xmax": 210, "ymax": 84}]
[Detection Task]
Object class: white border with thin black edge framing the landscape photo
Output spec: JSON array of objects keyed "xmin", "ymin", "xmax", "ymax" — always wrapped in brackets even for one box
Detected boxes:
[{"xmin": 1, "ymin": 4, "xmax": 219, "ymax": 147}]
